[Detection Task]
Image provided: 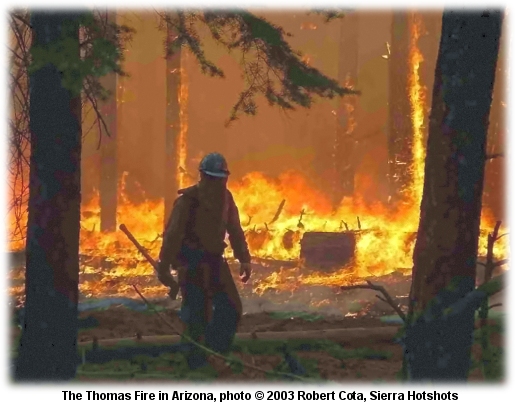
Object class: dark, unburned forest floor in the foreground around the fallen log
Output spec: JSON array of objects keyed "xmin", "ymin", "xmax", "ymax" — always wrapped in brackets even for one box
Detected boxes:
[{"xmin": 69, "ymin": 309, "xmax": 503, "ymax": 382}]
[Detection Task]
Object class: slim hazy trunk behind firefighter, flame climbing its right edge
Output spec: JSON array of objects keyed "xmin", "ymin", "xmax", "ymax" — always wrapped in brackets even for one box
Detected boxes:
[{"xmin": 164, "ymin": 16, "xmax": 181, "ymax": 225}]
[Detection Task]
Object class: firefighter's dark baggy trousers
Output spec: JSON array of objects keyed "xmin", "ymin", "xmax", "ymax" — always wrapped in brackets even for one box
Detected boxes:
[{"xmin": 179, "ymin": 246, "xmax": 242, "ymax": 353}]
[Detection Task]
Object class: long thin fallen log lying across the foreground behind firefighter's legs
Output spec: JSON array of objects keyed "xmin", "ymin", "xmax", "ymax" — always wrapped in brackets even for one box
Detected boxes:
[{"xmin": 79, "ymin": 326, "xmax": 400, "ymax": 347}]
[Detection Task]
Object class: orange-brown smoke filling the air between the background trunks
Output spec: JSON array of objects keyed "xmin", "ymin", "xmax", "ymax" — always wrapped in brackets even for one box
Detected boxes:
[{"xmin": 83, "ymin": 13, "xmax": 396, "ymax": 207}]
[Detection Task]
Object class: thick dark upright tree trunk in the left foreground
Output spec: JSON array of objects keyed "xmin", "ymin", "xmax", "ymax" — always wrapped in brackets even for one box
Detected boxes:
[{"xmin": 15, "ymin": 12, "xmax": 81, "ymax": 380}]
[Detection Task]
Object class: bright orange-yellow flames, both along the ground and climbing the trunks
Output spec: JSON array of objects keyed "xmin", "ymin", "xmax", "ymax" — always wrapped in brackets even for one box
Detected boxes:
[{"xmin": 9, "ymin": 17, "xmax": 508, "ymax": 297}]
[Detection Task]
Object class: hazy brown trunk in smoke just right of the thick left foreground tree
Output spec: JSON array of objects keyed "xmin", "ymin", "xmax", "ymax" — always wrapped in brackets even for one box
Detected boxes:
[{"xmin": 100, "ymin": 11, "xmax": 118, "ymax": 232}]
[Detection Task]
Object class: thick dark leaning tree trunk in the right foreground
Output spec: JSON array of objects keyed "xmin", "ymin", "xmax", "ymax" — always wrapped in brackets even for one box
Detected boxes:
[{"xmin": 405, "ymin": 11, "xmax": 502, "ymax": 381}]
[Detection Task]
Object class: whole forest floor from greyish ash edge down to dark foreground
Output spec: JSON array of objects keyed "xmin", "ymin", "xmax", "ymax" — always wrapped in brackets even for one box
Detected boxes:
[{"xmin": 11, "ymin": 260, "xmax": 504, "ymax": 382}]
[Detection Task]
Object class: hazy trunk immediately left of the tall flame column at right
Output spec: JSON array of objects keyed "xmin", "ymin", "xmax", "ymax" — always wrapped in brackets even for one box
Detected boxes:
[{"xmin": 388, "ymin": 11, "xmax": 412, "ymax": 204}]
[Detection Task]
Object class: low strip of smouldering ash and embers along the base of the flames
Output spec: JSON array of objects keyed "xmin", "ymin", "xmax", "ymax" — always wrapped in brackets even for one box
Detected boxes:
[{"xmin": 11, "ymin": 254, "xmax": 411, "ymax": 317}]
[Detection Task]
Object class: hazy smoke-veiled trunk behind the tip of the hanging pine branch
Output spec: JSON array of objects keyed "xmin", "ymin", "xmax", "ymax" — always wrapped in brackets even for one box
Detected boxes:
[{"xmin": 333, "ymin": 12, "xmax": 359, "ymax": 207}]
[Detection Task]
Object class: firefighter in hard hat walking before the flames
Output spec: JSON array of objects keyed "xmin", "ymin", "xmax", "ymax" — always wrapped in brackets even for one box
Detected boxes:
[{"xmin": 158, "ymin": 153, "xmax": 251, "ymax": 368}]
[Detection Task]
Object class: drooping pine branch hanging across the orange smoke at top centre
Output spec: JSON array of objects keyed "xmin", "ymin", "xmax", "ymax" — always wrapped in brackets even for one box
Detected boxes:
[{"xmin": 157, "ymin": 10, "xmax": 360, "ymax": 126}]
